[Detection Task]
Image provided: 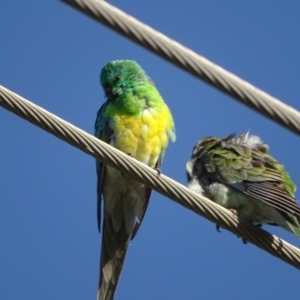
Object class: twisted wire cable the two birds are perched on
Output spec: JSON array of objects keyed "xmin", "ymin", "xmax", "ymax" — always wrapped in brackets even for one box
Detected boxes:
[{"xmin": 0, "ymin": 85, "xmax": 300, "ymax": 269}]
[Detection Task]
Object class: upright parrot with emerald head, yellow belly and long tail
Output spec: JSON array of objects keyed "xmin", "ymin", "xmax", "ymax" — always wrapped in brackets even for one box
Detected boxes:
[{"xmin": 95, "ymin": 60, "xmax": 176, "ymax": 300}]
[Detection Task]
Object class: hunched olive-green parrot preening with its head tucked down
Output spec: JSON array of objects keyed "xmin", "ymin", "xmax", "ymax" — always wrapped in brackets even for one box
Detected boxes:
[{"xmin": 186, "ymin": 133, "xmax": 300, "ymax": 237}]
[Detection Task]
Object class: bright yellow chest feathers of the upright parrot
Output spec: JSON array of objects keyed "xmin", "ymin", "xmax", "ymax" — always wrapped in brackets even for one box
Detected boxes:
[{"xmin": 110, "ymin": 108, "xmax": 167, "ymax": 166}]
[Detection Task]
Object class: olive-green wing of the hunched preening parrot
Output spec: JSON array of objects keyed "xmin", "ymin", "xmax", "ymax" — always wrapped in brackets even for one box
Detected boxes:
[{"xmin": 200, "ymin": 140, "xmax": 300, "ymax": 218}]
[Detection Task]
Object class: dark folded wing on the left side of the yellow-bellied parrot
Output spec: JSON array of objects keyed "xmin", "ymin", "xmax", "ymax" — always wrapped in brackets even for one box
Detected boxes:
[{"xmin": 95, "ymin": 101, "xmax": 113, "ymax": 232}]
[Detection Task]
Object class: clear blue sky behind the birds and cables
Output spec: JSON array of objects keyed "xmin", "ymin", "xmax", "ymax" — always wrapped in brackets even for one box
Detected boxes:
[{"xmin": 0, "ymin": 0, "xmax": 300, "ymax": 300}]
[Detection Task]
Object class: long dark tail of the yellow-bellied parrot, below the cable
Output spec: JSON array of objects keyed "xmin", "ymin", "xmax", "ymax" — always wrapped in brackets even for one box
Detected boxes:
[{"xmin": 97, "ymin": 205, "xmax": 131, "ymax": 300}]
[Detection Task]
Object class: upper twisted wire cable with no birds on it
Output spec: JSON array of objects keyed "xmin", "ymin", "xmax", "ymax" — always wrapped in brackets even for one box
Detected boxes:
[{"xmin": 61, "ymin": 0, "xmax": 300, "ymax": 135}]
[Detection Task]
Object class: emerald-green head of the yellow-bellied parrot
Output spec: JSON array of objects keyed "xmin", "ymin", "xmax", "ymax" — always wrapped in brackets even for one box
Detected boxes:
[{"xmin": 100, "ymin": 60, "xmax": 151, "ymax": 100}]
